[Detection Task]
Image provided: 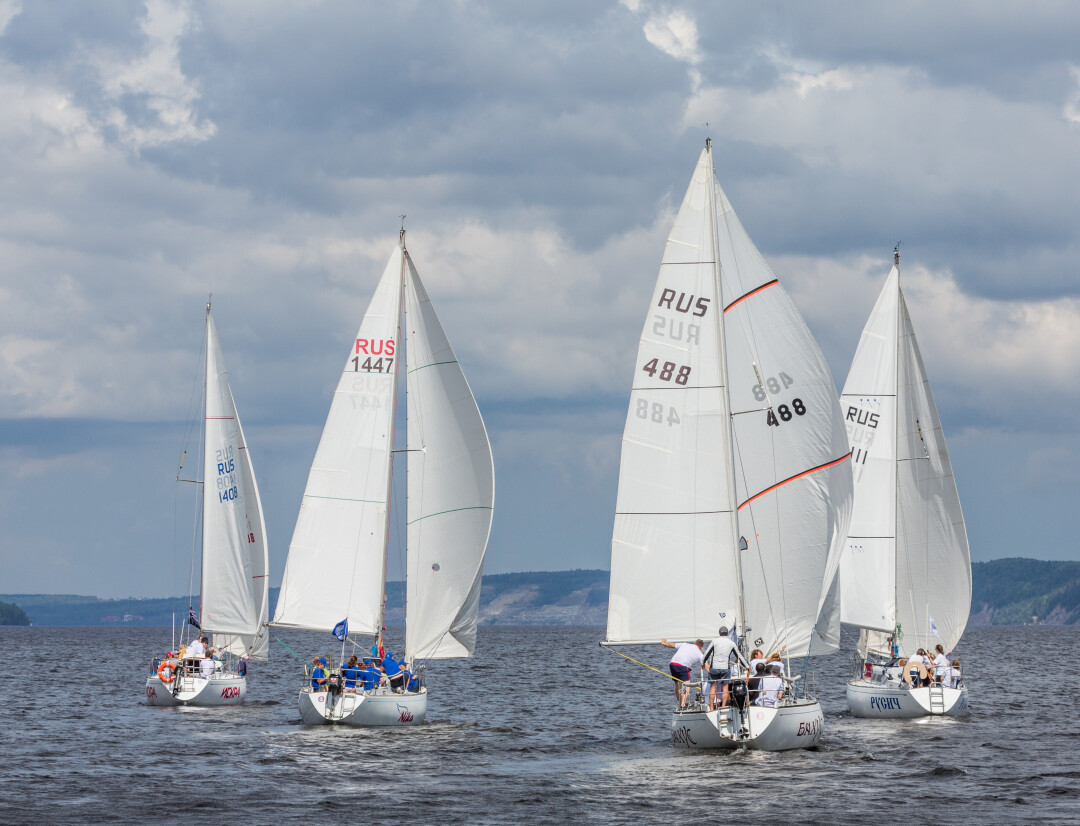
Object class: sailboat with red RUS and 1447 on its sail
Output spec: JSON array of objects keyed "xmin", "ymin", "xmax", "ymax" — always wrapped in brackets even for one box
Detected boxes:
[{"xmin": 272, "ymin": 229, "xmax": 495, "ymax": 726}]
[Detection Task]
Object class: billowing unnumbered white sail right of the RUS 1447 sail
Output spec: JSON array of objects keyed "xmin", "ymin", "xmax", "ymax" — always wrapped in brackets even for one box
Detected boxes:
[{"xmin": 405, "ymin": 253, "xmax": 495, "ymax": 660}]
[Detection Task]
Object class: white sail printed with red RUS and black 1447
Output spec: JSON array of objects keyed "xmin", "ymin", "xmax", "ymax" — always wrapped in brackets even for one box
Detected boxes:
[{"xmin": 274, "ymin": 247, "xmax": 403, "ymax": 634}]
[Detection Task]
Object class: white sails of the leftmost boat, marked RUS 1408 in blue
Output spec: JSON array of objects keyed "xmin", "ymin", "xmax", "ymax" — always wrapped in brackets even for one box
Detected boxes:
[{"xmin": 200, "ymin": 307, "xmax": 268, "ymax": 660}]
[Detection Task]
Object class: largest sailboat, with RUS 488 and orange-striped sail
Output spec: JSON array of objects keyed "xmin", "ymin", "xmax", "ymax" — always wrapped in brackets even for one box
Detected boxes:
[{"xmin": 602, "ymin": 140, "xmax": 852, "ymax": 750}]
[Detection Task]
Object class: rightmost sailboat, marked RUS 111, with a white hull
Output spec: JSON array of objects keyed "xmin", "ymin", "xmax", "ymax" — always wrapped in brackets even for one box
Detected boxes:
[{"xmin": 840, "ymin": 245, "xmax": 971, "ymax": 718}]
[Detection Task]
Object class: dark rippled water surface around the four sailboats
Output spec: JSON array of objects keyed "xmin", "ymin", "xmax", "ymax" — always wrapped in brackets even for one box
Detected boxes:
[{"xmin": 0, "ymin": 626, "xmax": 1080, "ymax": 824}]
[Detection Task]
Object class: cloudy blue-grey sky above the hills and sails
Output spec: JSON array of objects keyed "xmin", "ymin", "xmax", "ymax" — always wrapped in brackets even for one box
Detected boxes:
[{"xmin": 0, "ymin": 0, "xmax": 1080, "ymax": 597}]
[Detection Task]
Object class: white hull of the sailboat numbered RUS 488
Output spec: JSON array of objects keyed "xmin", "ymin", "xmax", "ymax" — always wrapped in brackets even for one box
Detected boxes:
[{"xmin": 672, "ymin": 700, "xmax": 824, "ymax": 751}]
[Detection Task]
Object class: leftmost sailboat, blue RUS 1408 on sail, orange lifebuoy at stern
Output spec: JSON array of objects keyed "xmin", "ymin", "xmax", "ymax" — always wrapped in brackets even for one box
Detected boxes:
[{"xmin": 146, "ymin": 303, "xmax": 269, "ymax": 706}]
